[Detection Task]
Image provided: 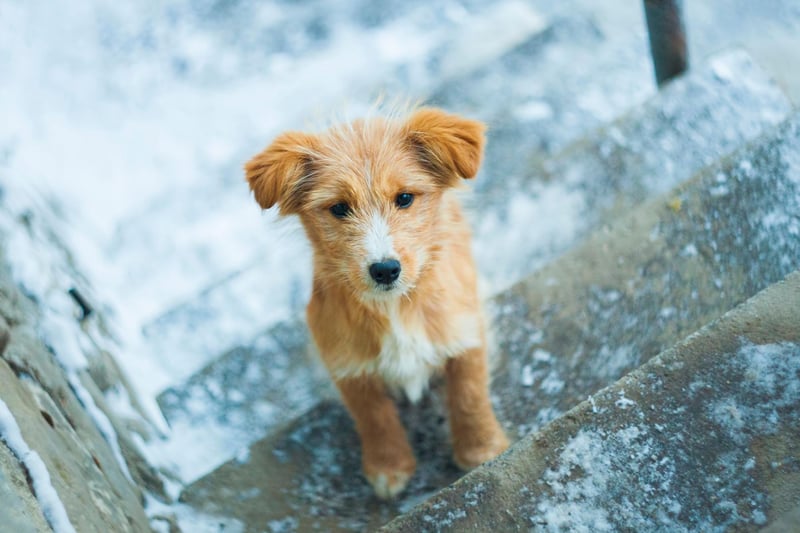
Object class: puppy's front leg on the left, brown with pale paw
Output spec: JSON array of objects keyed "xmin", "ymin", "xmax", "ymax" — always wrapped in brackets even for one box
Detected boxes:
[{"xmin": 336, "ymin": 376, "xmax": 416, "ymax": 499}]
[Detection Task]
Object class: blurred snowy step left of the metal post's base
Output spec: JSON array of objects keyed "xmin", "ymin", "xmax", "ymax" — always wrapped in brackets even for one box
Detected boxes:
[{"xmin": 428, "ymin": 13, "xmax": 656, "ymax": 170}]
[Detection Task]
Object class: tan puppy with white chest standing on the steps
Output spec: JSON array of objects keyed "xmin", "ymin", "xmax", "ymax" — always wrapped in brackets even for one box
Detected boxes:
[{"xmin": 245, "ymin": 108, "xmax": 508, "ymax": 499}]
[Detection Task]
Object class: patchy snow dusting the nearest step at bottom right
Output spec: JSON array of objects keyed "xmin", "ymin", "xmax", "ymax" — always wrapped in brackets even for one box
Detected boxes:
[{"xmin": 521, "ymin": 339, "xmax": 800, "ymax": 532}]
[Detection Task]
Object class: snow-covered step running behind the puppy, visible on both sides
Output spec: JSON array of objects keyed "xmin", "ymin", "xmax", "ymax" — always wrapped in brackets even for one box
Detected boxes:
[{"xmin": 145, "ymin": 50, "xmax": 790, "ymax": 400}]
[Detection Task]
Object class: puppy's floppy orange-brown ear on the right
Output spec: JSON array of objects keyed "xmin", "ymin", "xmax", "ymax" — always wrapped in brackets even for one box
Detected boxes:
[{"xmin": 407, "ymin": 108, "xmax": 486, "ymax": 185}]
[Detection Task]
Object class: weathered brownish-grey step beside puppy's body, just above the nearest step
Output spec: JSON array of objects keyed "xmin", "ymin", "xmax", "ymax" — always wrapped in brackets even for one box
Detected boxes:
[{"xmin": 493, "ymin": 110, "xmax": 800, "ymax": 435}]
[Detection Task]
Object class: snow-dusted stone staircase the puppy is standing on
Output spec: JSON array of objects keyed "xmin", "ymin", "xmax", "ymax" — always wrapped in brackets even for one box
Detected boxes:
[{"xmin": 153, "ymin": 36, "xmax": 800, "ymax": 531}]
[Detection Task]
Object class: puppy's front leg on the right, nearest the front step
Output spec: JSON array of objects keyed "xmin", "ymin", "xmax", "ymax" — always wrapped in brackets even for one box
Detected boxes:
[{"xmin": 445, "ymin": 342, "xmax": 508, "ymax": 470}]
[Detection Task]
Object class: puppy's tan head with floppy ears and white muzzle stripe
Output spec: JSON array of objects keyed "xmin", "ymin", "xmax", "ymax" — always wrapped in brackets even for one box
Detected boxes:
[{"xmin": 245, "ymin": 108, "xmax": 485, "ymax": 301}]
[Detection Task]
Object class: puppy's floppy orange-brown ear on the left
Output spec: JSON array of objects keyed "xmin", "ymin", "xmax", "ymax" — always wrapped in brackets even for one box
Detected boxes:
[{"xmin": 244, "ymin": 132, "xmax": 317, "ymax": 215}]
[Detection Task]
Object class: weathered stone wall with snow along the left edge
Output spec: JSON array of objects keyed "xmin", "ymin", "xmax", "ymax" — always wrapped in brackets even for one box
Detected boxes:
[{"xmin": 0, "ymin": 218, "xmax": 157, "ymax": 532}]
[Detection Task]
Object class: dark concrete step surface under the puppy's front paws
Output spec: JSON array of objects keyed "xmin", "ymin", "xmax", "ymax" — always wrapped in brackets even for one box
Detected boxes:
[{"xmin": 180, "ymin": 386, "xmax": 461, "ymax": 531}]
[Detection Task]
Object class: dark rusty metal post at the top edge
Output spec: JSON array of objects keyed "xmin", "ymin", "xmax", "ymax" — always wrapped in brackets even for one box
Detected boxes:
[{"xmin": 644, "ymin": 0, "xmax": 689, "ymax": 86}]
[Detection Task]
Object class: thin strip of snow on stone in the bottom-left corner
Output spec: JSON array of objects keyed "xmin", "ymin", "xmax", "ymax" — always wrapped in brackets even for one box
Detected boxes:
[{"xmin": 0, "ymin": 400, "xmax": 75, "ymax": 533}]
